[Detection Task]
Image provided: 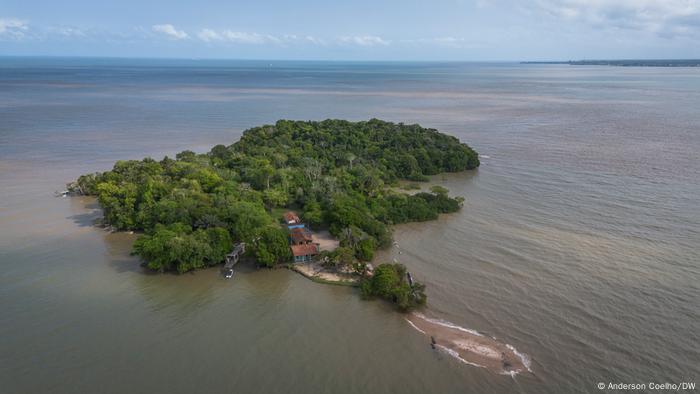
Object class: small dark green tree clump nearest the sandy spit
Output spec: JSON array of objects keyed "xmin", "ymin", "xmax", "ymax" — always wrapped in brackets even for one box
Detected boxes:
[{"xmin": 360, "ymin": 264, "xmax": 426, "ymax": 311}]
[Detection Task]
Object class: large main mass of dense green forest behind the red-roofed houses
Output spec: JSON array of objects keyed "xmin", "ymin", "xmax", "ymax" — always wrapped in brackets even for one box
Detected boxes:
[{"xmin": 69, "ymin": 119, "xmax": 479, "ymax": 272}]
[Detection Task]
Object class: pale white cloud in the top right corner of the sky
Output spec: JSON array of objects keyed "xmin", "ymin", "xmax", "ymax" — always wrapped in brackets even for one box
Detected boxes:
[{"xmin": 538, "ymin": 0, "xmax": 700, "ymax": 36}]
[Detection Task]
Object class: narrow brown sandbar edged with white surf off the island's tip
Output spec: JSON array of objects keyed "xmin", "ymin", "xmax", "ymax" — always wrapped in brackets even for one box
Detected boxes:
[{"xmin": 406, "ymin": 313, "xmax": 531, "ymax": 375}]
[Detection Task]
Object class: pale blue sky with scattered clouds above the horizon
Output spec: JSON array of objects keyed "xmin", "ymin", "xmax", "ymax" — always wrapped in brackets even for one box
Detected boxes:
[{"xmin": 0, "ymin": 0, "xmax": 700, "ymax": 61}]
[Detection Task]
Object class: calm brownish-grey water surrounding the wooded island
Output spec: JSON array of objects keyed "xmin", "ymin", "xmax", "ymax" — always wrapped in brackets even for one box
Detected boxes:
[{"xmin": 0, "ymin": 58, "xmax": 700, "ymax": 393}]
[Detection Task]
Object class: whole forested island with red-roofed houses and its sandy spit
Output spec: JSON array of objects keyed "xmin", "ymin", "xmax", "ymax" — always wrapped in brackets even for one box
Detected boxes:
[{"xmin": 68, "ymin": 119, "xmax": 536, "ymax": 374}]
